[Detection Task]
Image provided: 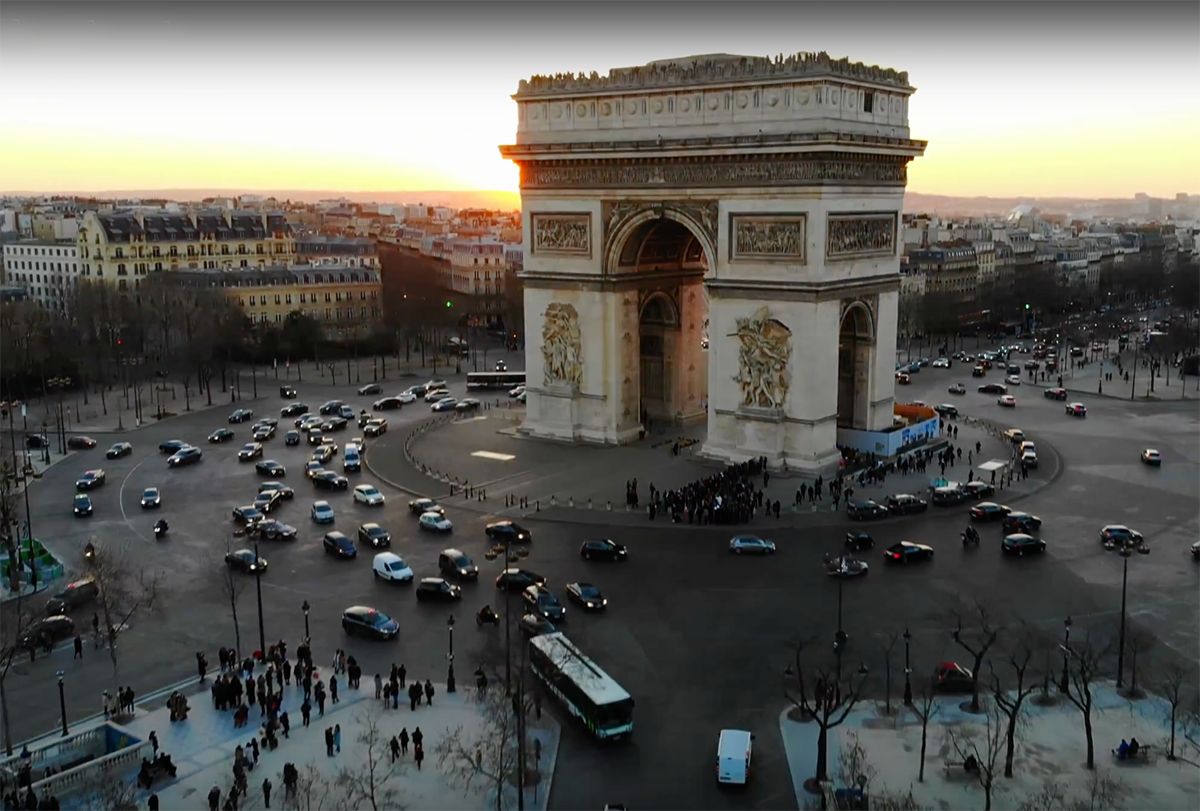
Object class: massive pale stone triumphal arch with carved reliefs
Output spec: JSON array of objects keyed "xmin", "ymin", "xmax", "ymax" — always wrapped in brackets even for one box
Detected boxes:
[{"xmin": 500, "ymin": 53, "xmax": 925, "ymax": 473}]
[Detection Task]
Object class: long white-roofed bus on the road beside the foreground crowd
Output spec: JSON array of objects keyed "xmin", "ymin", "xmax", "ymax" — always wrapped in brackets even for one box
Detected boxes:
[{"xmin": 529, "ymin": 633, "xmax": 634, "ymax": 740}]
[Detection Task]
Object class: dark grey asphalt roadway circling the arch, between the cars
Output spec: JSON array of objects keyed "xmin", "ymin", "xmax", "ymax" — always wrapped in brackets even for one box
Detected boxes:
[{"xmin": 6, "ymin": 338, "xmax": 1200, "ymax": 811}]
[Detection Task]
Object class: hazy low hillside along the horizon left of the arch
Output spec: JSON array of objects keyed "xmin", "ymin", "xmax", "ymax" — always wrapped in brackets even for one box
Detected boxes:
[{"xmin": 6, "ymin": 188, "xmax": 521, "ymax": 211}]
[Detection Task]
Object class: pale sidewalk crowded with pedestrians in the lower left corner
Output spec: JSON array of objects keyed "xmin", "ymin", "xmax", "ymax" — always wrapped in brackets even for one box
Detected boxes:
[{"xmin": 54, "ymin": 668, "xmax": 560, "ymax": 811}]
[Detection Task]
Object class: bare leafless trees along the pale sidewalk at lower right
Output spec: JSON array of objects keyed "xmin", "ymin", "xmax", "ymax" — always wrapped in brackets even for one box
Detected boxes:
[{"xmin": 785, "ymin": 602, "xmax": 1200, "ymax": 811}]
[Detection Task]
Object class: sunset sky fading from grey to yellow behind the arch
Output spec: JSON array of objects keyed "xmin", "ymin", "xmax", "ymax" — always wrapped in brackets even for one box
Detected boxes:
[{"xmin": 0, "ymin": 0, "xmax": 1200, "ymax": 197}]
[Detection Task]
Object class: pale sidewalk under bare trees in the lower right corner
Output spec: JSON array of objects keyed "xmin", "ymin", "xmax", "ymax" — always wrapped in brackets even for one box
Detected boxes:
[{"xmin": 780, "ymin": 684, "xmax": 1200, "ymax": 811}]
